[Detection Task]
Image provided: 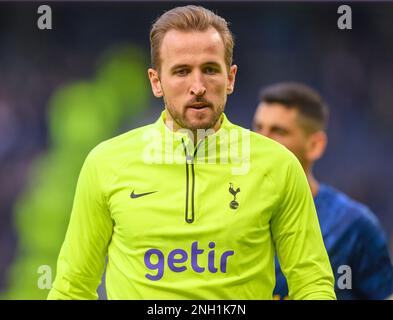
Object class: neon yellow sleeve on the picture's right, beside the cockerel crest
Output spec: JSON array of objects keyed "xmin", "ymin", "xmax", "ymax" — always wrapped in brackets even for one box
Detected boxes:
[{"xmin": 271, "ymin": 158, "xmax": 335, "ymax": 300}]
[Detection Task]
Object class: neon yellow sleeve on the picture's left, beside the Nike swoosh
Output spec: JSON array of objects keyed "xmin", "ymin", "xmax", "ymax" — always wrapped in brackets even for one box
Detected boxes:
[{"xmin": 48, "ymin": 151, "xmax": 113, "ymax": 299}]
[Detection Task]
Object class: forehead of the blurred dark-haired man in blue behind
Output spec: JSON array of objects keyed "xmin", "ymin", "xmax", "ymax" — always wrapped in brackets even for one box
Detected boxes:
[{"xmin": 255, "ymin": 102, "xmax": 298, "ymax": 125}]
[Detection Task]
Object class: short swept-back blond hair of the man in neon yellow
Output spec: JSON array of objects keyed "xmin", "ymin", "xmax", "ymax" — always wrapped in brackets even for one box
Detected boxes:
[{"xmin": 150, "ymin": 5, "xmax": 234, "ymax": 71}]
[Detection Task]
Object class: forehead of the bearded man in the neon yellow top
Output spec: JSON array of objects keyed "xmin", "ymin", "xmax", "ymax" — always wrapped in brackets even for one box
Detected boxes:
[{"xmin": 160, "ymin": 27, "xmax": 225, "ymax": 64}]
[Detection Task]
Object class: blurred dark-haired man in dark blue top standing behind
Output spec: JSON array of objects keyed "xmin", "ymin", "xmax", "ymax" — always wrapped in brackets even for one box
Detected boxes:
[{"xmin": 253, "ymin": 83, "xmax": 393, "ymax": 299}]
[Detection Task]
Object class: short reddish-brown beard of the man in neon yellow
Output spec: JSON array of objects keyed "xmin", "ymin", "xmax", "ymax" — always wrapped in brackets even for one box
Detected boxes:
[{"xmin": 164, "ymin": 97, "xmax": 225, "ymax": 132}]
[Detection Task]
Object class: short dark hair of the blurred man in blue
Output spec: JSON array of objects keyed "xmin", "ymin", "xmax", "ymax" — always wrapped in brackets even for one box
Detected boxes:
[{"xmin": 259, "ymin": 82, "xmax": 329, "ymax": 132}]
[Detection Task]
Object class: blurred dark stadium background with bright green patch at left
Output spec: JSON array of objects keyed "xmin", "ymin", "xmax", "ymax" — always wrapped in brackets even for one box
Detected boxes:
[{"xmin": 0, "ymin": 2, "xmax": 393, "ymax": 299}]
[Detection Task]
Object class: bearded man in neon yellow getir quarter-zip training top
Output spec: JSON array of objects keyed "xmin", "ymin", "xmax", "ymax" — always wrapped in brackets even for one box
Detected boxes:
[{"xmin": 49, "ymin": 6, "xmax": 335, "ymax": 299}]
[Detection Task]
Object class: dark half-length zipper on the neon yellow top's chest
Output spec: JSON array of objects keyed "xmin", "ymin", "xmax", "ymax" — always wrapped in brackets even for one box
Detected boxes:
[{"xmin": 182, "ymin": 139, "xmax": 203, "ymax": 223}]
